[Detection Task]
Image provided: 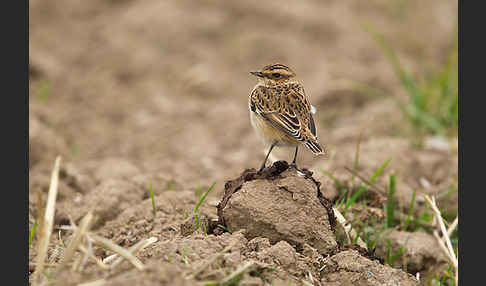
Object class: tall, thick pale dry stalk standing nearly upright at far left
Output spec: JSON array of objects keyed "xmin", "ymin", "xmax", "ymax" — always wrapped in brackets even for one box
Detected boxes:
[{"xmin": 34, "ymin": 156, "xmax": 61, "ymax": 284}]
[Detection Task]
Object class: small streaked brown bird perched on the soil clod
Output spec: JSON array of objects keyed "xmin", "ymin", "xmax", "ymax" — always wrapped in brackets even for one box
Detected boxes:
[{"xmin": 248, "ymin": 63, "xmax": 327, "ymax": 172}]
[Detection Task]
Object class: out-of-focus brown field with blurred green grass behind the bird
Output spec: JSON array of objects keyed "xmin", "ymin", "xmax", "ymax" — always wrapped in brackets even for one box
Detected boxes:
[{"xmin": 29, "ymin": 0, "xmax": 458, "ymax": 282}]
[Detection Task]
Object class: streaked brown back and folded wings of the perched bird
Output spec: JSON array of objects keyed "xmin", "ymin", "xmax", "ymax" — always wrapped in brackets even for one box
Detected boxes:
[{"xmin": 250, "ymin": 86, "xmax": 316, "ymax": 141}]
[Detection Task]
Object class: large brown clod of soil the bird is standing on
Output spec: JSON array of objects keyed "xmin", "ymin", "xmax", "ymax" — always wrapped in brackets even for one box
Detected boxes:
[{"xmin": 218, "ymin": 161, "xmax": 338, "ymax": 255}]
